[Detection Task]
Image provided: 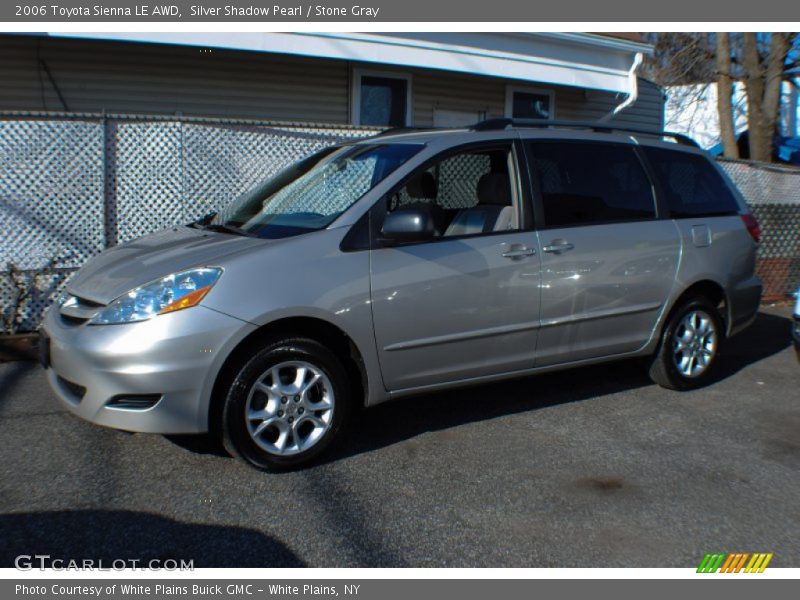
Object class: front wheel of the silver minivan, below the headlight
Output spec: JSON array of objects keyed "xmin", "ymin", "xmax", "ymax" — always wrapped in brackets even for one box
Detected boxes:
[{"xmin": 222, "ymin": 338, "xmax": 351, "ymax": 471}]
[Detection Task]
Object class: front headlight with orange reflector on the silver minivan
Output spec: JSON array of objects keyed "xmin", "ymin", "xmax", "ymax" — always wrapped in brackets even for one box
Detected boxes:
[{"xmin": 89, "ymin": 267, "xmax": 222, "ymax": 325}]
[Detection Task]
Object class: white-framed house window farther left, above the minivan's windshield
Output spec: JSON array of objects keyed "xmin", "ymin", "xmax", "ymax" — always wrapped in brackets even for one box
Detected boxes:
[{"xmin": 353, "ymin": 70, "xmax": 411, "ymax": 127}]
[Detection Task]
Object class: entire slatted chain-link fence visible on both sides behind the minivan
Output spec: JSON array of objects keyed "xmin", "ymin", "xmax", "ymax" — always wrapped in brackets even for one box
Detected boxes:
[{"xmin": 0, "ymin": 113, "xmax": 800, "ymax": 333}]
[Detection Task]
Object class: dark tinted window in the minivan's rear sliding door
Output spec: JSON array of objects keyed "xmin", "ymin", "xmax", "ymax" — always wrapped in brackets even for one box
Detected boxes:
[{"xmin": 527, "ymin": 142, "xmax": 655, "ymax": 227}]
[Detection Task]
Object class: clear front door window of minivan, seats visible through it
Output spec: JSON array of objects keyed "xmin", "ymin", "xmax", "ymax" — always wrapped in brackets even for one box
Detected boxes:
[{"xmin": 389, "ymin": 148, "xmax": 518, "ymax": 237}]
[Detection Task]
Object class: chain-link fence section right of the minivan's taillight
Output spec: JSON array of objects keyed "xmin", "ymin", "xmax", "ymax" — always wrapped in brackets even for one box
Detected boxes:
[{"xmin": 720, "ymin": 159, "xmax": 800, "ymax": 301}]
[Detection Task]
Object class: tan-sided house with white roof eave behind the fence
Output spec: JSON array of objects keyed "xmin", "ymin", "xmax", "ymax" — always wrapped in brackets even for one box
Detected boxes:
[{"xmin": 0, "ymin": 32, "xmax": 663, "ymax": 129}]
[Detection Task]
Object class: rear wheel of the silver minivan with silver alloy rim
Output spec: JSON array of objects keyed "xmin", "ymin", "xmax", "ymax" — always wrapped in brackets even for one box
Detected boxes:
[{"xmin": 649, "ymin": 297, "xmax": 725, "ymax": 390}]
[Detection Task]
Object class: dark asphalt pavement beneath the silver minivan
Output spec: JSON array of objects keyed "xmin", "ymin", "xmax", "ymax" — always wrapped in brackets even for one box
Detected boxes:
[{"xmin": 0, "ymin": 309, "xmax": 800, "ymax": 567}]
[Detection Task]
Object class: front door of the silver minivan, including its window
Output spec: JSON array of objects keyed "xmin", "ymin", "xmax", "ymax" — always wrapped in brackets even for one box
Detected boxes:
[{"xmin": 371, "ymin": 142, "xmax": 540, "ymax": 391}]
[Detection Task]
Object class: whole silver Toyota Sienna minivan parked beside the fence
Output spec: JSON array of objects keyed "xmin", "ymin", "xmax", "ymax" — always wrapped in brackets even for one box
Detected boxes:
[{"xmin": 42, "ymin": 119, "xmax": 761, "ymax": 469}]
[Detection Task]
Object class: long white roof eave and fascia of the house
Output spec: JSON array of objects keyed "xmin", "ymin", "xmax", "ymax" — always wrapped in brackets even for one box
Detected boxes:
[{"xmin": 43, "ymin": 31, "xmax": 652, "ymax": 93}]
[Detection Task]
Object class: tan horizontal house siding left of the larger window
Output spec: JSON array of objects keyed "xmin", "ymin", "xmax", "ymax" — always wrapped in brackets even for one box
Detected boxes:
[{"xmin": 0, "ymin": 35, "xmax": 349, "ymax": 123}]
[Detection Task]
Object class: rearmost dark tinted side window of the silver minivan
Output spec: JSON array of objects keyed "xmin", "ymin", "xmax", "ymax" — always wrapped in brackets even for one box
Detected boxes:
[{"xmin": 643, "ymin": 147, "xmax": 739, "ymax": 219}]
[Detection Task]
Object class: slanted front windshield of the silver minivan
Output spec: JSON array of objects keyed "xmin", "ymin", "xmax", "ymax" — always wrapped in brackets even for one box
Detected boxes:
[{"xmin": 208, "ymin": 144, "xmax": 422, "ymax": 238}]
